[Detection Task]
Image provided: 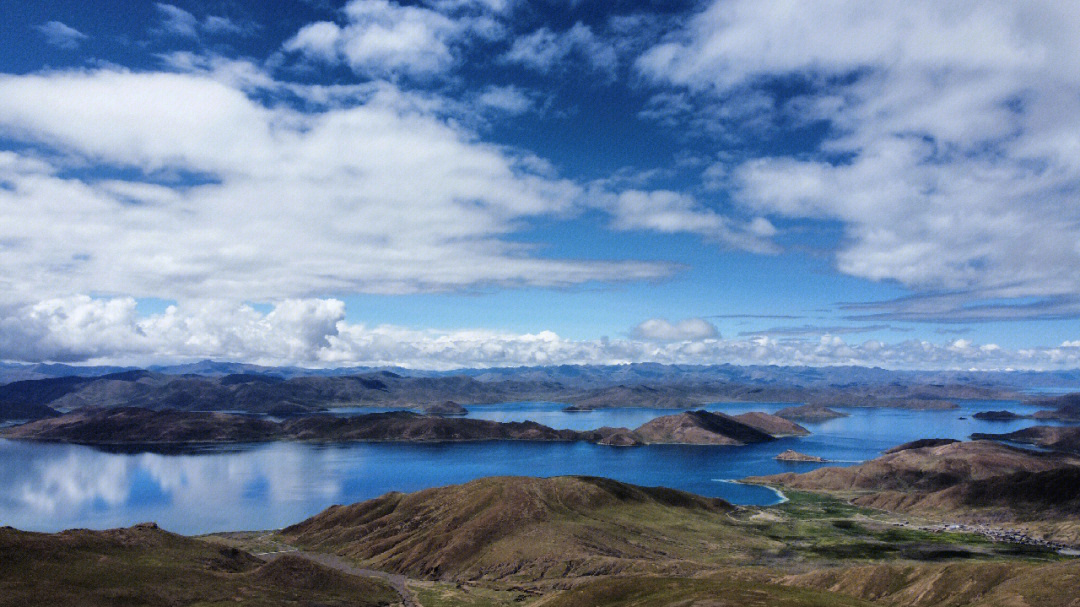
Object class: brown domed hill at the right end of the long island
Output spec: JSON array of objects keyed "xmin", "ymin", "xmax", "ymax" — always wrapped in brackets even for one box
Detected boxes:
[{"xmin": 634, "ymin": 410, "xmax": 773, "ymax": 445}]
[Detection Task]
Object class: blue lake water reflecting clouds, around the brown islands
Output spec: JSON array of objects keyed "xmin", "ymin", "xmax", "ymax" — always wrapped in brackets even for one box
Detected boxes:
[{"xmin": 0, "ymin": 401, "xmax": 1071, "ymax": 534}]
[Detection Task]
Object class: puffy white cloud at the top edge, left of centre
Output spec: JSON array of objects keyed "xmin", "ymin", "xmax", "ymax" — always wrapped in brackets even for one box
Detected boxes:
[{"xmin": 284, "ymin": 0, "xmax": 500, "ymax": 77}]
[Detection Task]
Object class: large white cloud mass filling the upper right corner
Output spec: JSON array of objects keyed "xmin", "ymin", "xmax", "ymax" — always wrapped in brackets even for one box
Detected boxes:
[{"xmin": 637, "ymin": 0, "xmax": 1080, "ymax": 316}]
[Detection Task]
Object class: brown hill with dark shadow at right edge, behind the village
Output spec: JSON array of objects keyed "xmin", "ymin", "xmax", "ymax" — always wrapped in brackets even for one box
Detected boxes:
[{"xmin": 746, "ymin": 441, "xmax": 1080, "ymax": 544}]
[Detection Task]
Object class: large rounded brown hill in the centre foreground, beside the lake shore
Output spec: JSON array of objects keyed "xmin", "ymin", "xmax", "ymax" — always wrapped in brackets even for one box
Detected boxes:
[{"xmin": 282, "ymin": 476, "xmax": 768, "ymax": 581}]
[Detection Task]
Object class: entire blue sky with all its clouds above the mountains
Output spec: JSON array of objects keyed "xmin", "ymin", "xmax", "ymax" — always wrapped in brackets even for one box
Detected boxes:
[{"xmin": 0, "ymin": 0, "xmax": 1080, "ymax": 368}]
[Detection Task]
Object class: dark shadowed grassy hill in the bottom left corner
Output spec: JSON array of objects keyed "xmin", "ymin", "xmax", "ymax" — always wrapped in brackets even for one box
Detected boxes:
[{"xmin": 0, "ymin": 525, "xmax": 399, "ymax": 607}]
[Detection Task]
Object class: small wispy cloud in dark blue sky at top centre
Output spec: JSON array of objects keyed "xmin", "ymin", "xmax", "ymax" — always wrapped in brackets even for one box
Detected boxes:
[{"xmin": 502, "ymin": 23, "xmax": 619, "ymax": 77}]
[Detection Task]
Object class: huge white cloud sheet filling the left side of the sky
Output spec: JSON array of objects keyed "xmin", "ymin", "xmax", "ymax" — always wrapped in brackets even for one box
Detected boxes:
[{"xmin": 0, "ymin": 64, "xmax": 673, "ymax": 302}]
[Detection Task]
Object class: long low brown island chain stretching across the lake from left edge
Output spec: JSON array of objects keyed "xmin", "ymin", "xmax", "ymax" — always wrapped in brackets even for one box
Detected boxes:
[{"xmin": 0, "ymin": 407, "xmax": 809, "ymax": 449}]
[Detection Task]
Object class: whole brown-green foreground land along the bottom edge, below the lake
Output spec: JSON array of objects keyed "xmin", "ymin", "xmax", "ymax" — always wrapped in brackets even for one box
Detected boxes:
[{"xmin": 10, "ymin": 477, "xmax": 1080, "ymax": 607}]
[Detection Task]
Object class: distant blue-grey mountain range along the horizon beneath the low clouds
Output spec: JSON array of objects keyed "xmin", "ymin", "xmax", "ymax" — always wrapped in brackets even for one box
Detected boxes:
[{"xmin": 0, "ymin": 363, "xmax": 1021, "ymax": 419}]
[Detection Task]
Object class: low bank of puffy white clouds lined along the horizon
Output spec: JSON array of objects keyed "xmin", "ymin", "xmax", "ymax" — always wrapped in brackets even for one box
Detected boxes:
[{"xmin": 0, "ymin": 296, "xmax": 1080, "ymax": 369}]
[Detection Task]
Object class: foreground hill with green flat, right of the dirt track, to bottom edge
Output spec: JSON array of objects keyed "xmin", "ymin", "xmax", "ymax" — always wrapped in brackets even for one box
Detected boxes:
[{"xmin": 280, "ymin": 476, "xmax": 1080, "ymax": 607}]
